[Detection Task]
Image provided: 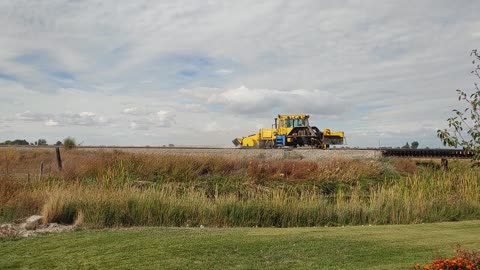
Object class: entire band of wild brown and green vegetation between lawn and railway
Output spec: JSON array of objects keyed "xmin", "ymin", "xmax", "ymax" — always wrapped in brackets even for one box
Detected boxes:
[{"xmin": 0, "ymin": 148, "xmax": 480, "ymax": 228}]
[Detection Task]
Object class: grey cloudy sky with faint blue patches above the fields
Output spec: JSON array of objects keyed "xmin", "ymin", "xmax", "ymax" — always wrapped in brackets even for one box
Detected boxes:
[{"xmin": 0, "ymin": 0, "xmax": 480, "ymax": 147}]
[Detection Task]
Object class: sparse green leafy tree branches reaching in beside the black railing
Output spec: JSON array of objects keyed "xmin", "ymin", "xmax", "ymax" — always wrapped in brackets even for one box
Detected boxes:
[{"xmin": 437, "ymin": 50, "xmax": 480, "ymax": 160}]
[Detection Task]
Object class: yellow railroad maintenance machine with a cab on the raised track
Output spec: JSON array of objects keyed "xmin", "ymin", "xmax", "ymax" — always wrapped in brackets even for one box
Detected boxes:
[{"xmin": 232, "ymin": 114, "xmax": 345, "ymax": 149}]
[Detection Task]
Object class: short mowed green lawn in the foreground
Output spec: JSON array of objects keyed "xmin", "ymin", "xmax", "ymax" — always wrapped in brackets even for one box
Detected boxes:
[{"xmin": 0, "ymin": 221, "xmax": 480, "ymax": 269}]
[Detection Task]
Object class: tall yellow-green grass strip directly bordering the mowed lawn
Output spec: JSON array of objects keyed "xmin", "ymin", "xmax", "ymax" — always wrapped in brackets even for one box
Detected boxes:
[{"xmin": 34, "ymin": 172, "xmax": 480, "ymax": 227}]
